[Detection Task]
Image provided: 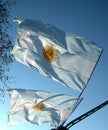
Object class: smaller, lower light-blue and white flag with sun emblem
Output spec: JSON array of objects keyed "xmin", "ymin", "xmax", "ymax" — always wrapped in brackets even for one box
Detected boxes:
[{"xmin": 6, "ymin": 89, "xmax": 80, "ymax": 128}]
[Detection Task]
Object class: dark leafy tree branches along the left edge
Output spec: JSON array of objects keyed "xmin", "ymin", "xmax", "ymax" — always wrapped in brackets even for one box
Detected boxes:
[{"xmin": 0, "ymin": 0, "xmax": 16, "ymax": 95}]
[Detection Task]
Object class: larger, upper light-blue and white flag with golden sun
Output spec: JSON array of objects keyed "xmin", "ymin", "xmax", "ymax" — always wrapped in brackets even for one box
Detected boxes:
[{"xmin": 12, "ymin": 19, "xmax": 102, "ymax": 92}]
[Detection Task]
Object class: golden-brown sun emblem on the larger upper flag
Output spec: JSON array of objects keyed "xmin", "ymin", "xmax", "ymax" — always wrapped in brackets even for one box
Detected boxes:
[{"xmin": 43, "ymin": 45, "xmax": 57, "ymax": 62}]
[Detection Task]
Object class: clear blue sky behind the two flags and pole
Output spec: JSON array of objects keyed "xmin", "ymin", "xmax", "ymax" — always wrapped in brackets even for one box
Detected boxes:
[{"xmin": 0, "ymin": 0, "xmax": 108, "ymax": 130}]
